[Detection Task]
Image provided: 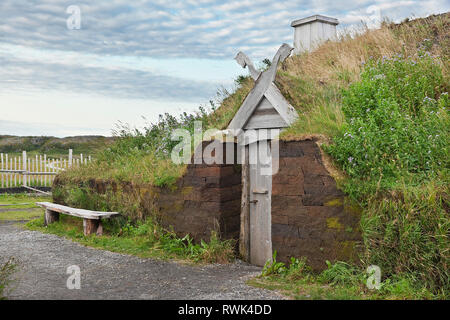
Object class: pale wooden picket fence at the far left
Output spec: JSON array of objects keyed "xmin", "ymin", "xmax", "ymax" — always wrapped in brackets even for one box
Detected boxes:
[{"xmin": 0, "ymin": 149, "xmax": 91, "ymax": 188}]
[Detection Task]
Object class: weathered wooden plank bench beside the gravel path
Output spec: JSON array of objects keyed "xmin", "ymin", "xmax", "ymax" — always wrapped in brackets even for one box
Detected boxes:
[{"xmin": 36, "ymin": 202, "xmax": 119, "ymax": 236}]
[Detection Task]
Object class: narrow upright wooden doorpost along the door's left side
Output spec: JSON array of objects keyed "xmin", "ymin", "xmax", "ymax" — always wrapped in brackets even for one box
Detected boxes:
[{"xmin": 238, "ymin": 145, "xmax": 250, "ymax": 261}]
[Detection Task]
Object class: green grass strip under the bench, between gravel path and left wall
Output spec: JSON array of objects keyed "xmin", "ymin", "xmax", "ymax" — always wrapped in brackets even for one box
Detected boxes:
[{"xmin": 25, "ymin": 215, "xmax": 234, "ymax": 264}]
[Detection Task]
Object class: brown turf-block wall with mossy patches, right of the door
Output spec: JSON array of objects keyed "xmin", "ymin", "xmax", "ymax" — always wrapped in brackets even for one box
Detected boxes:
[{"xmin": 272, "ymin": 139, "xmax": 361, "ymax": 270}]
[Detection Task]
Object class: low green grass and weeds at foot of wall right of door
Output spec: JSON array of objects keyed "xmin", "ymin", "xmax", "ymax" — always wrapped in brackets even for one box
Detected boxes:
[{"xmin": 247, "ymin": 257, "xmax": 449, "ymax": 300}]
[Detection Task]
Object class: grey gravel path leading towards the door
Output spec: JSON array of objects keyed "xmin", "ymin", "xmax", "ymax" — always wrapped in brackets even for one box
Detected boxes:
[{"xmin": 0, "ymin": 222, "xmax": 282, "ymax": 300}]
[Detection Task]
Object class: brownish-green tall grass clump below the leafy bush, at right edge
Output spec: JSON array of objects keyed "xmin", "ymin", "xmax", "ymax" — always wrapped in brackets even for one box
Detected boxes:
[{"xmin": 361, "ymin": 182, "xmax": 450, "ymax": 293}]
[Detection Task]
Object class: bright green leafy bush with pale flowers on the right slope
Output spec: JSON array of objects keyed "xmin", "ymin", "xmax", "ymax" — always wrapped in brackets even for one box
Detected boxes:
[{"xmin": 328, "ymin": 54, "xmax": 450, "ymax": 179}]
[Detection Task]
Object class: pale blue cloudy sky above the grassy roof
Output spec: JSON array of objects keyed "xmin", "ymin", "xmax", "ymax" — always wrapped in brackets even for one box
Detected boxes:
[{"xmin": 0, "ymin": 0, "xmax": 450, "ymax": 136}]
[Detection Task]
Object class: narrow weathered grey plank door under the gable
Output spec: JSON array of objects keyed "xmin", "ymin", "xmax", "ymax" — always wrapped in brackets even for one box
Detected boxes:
[{"xmin": 249, "ymin": 140, "xmax": 272, "ymax": 266}]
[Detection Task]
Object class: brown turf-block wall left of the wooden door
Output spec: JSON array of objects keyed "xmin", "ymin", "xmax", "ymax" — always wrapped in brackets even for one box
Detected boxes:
[{"xmin": 155, "ymin": 142, "xmax": 242, "ymax": 241}]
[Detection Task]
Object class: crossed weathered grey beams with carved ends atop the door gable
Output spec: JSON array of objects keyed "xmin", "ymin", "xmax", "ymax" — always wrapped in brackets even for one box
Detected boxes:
[{"xmin": 228, "ymin": 43, "xmax": 298, "ymax": 130}]
